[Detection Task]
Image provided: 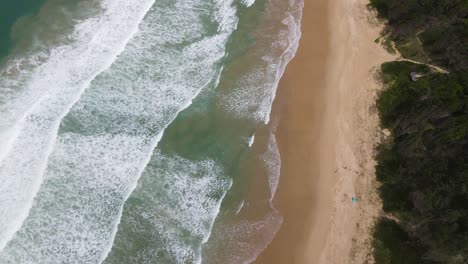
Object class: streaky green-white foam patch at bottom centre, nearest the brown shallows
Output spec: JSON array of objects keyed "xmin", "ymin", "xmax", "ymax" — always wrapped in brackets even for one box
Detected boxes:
[{"xmin": 107, "ymin": 150, "xmax": 231, "ymax": 263}]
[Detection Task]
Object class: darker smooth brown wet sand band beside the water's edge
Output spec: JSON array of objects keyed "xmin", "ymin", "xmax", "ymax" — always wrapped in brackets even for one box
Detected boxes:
[{"xmin": 255, "ymin": 0, "xmax": 334, "ymax": 264}]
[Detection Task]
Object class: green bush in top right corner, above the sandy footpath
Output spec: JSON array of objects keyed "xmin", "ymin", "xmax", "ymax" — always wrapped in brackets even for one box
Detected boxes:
[{"xmin": 371, "ymin": 0, "xmax": 468, "ymax": 70}]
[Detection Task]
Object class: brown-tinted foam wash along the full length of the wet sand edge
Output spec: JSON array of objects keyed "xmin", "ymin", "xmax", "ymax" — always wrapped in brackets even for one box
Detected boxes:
[{"xmin": 205, "ymin": 0, "xmax": 303, "ymax": 264}]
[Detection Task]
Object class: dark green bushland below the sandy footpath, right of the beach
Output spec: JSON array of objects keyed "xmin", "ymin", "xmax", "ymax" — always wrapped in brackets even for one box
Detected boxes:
[{"xmin": 375, "ymin": 62, "xmax": 468, "ymax": 264}]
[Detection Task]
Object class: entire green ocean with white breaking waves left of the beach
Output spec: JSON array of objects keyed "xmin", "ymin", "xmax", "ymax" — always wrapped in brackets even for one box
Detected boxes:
[{"xmin": 0, "ymin": 0, "xmax": 303, "ymax": 264}]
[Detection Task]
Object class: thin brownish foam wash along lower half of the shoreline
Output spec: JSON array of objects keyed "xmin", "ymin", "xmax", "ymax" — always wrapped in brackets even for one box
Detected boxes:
[{"xmin": 200, "ymin": 131, "xmax": 283, "ymax": 264}]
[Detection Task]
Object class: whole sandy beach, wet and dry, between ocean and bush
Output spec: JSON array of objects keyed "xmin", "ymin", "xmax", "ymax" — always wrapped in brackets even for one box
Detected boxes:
[{"xmin": 255, "ymin": 0, "xmax": 393, "ymax": 264}]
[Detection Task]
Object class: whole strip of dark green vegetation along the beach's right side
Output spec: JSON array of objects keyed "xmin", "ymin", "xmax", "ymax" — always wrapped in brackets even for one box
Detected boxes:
[{"xmin": 371, "ymin": 0, "xmax": 468, "ymax": 264}]
